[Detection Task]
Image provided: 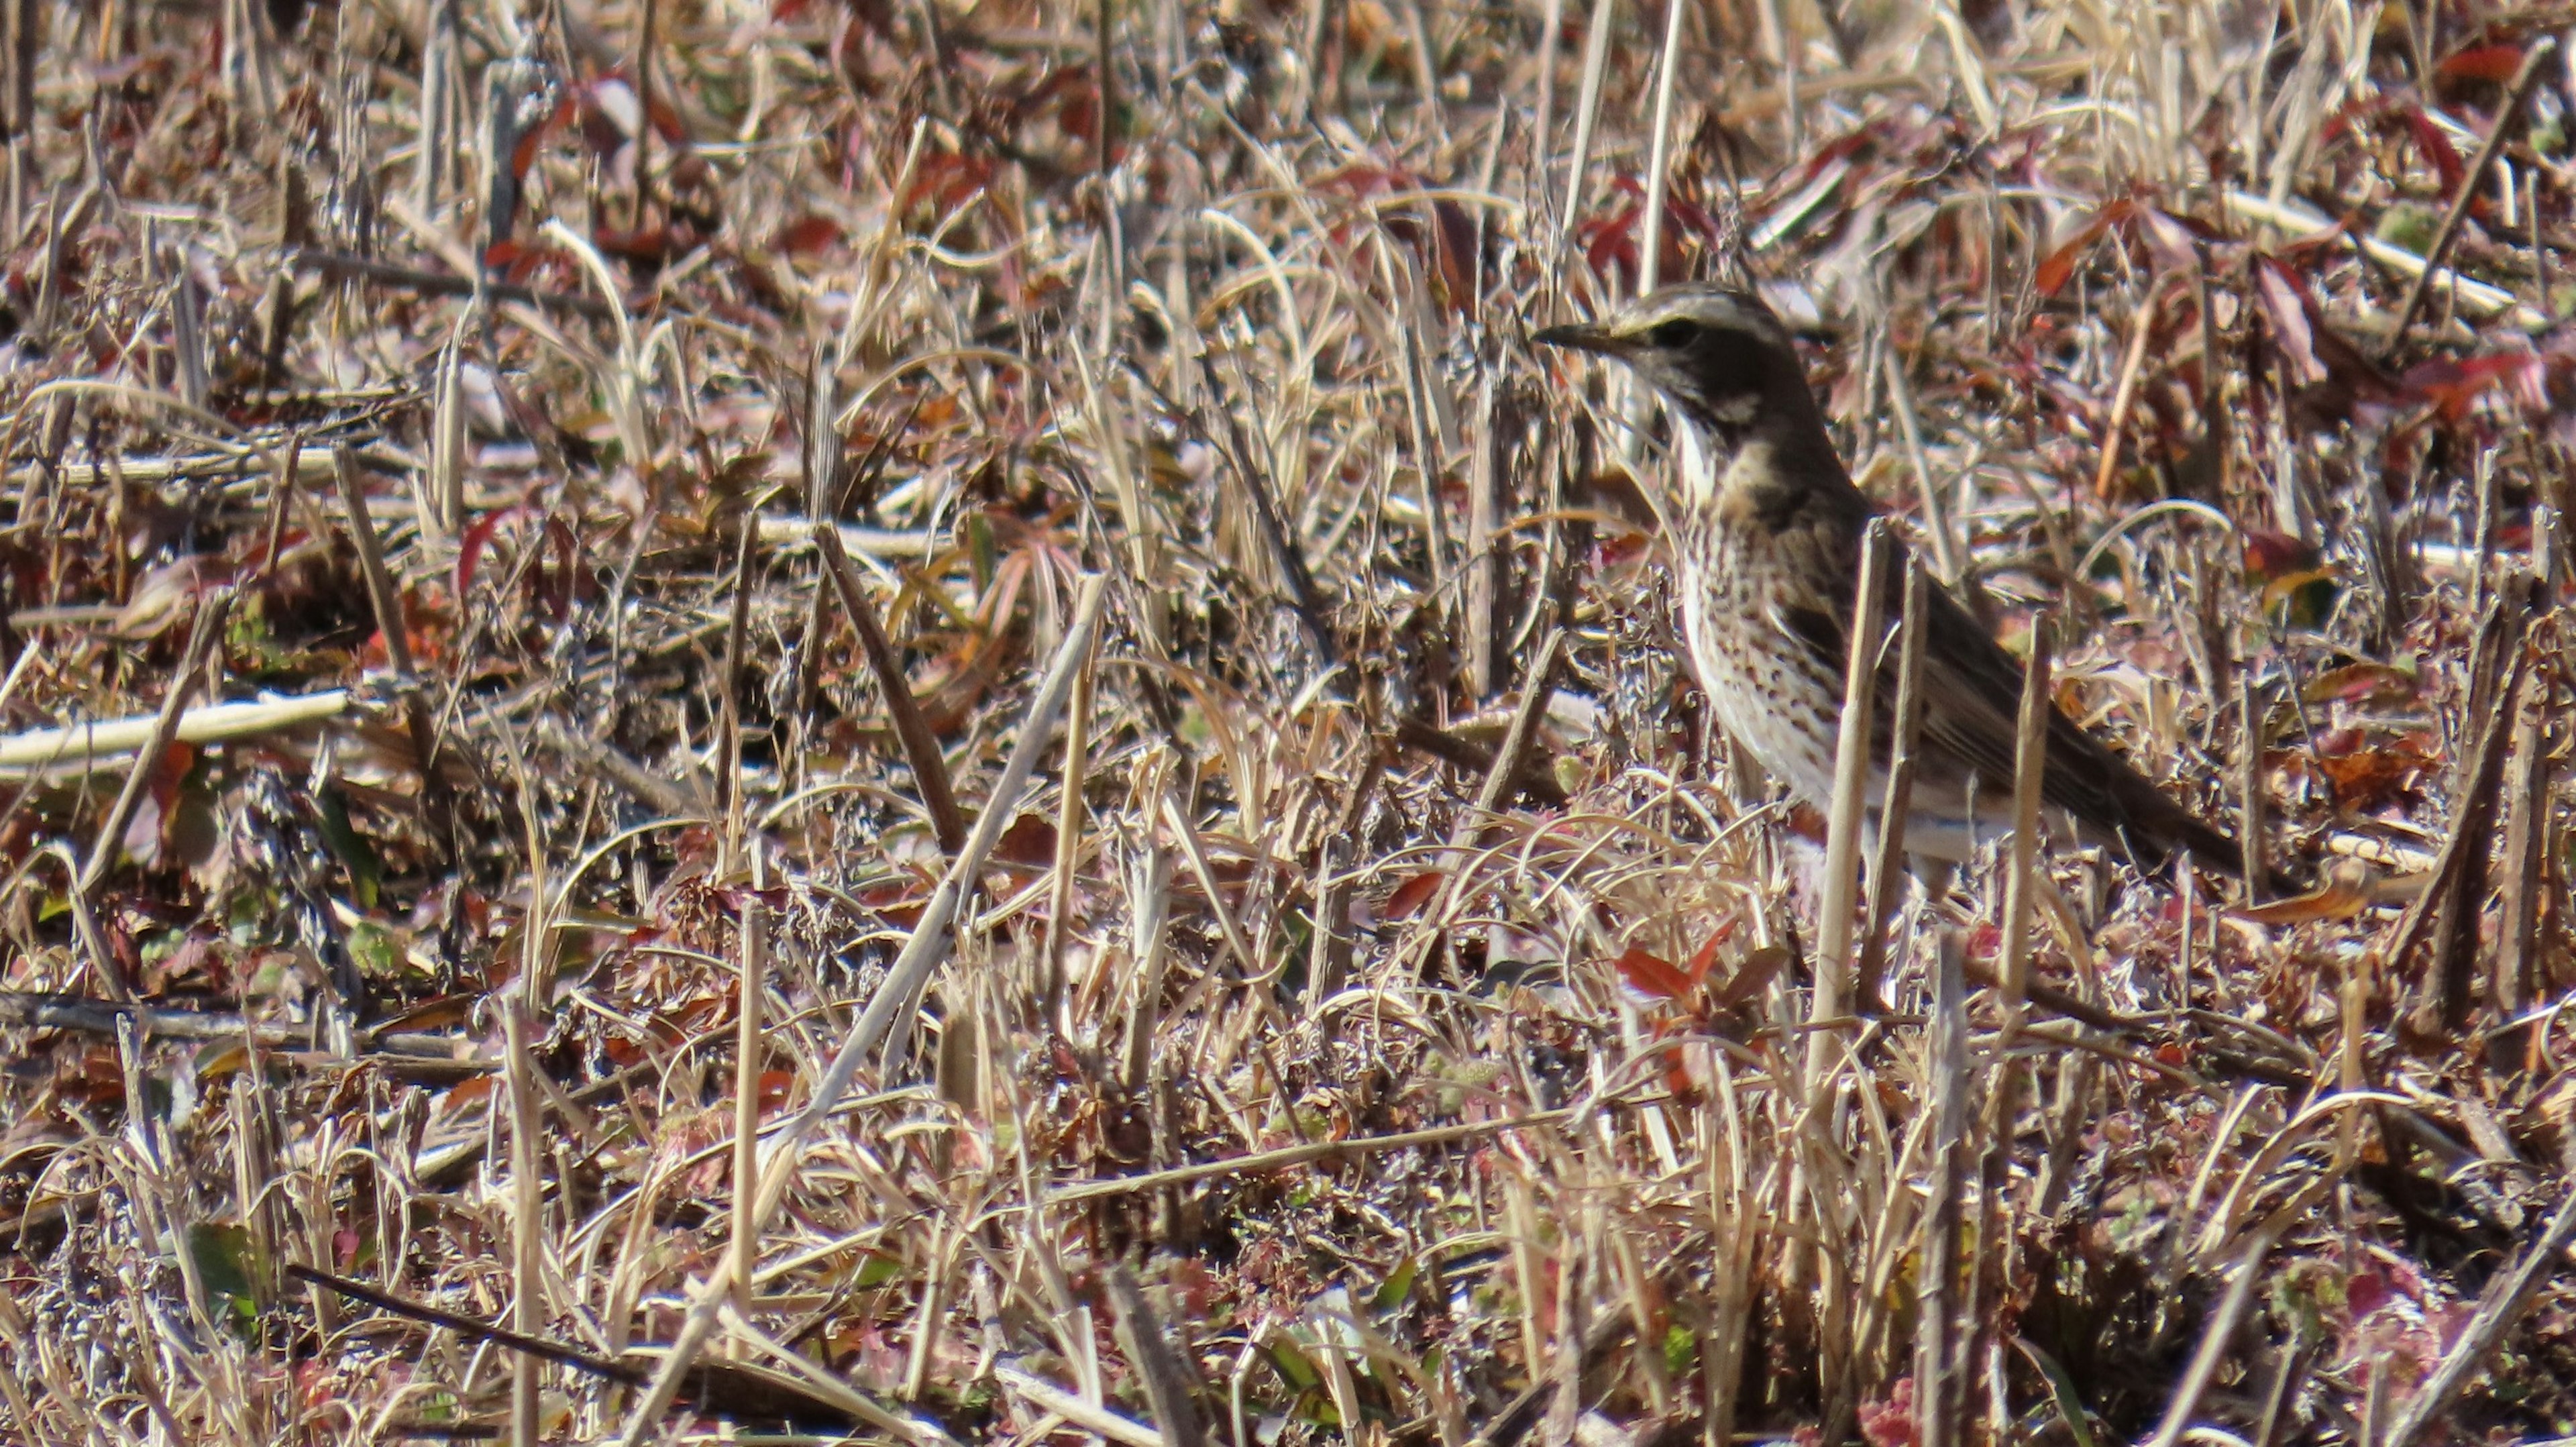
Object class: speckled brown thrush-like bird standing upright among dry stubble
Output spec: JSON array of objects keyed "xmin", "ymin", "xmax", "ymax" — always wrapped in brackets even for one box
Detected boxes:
[{"xmin": 1533, "ymin": 283, "xmax": 2244, "ymax": 891}]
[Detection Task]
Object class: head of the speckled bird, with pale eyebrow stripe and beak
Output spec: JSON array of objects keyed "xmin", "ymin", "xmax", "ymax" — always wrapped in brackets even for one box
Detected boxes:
[{"xmin": 1536, "ymin": 283, "xmax": 1813, "ymax": 435}]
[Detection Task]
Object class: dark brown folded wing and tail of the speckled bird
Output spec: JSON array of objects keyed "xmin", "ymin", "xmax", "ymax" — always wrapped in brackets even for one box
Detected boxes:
[{"xmin": 1780, "ymin": 574, "xmax": 2244, "ymax": 873}]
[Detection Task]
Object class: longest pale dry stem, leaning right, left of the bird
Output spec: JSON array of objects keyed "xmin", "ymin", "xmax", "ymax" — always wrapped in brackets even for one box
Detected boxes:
[{"xmin": 619, "ymin": 574, "xmax": 1108, "ymax": 1447}]
